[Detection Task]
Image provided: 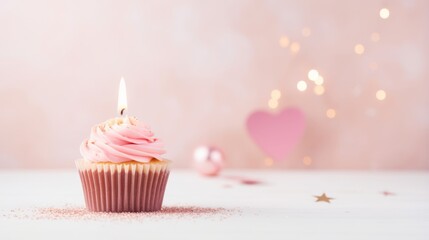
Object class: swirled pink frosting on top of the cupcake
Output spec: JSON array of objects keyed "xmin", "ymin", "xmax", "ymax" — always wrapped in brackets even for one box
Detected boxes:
[{"xmin": 80, "ymin": 116, "xmax": 165, "ymax": 163}]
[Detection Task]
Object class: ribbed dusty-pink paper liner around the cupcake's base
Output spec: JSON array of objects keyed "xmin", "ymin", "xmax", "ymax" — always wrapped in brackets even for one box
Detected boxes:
[{"xmin": 76, "ymin": 159, "xmax": 169, "ymax": 212}]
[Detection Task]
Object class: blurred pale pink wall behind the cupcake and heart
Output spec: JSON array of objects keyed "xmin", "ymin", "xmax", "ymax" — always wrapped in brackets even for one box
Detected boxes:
[{"xmin": 0, "ymin": 0, "xmax": 429, "ymax": 169}]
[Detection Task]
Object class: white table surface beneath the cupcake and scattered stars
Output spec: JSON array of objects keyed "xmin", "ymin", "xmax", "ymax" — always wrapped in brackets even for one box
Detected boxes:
[{"xmin": 0, "ymin": 170, "xmax": 429, "ymax": 240}]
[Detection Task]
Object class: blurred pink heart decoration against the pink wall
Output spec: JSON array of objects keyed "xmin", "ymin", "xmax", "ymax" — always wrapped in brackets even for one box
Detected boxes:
[{"xmin": 247, "ymin": 108, "xmax": 305, "ymax": 161}]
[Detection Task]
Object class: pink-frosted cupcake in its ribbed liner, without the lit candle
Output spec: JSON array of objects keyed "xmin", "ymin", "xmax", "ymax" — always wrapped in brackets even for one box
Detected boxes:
[{"xmin": 76, "ymin": 116, "xmax": 169, "ymax": 212}]
